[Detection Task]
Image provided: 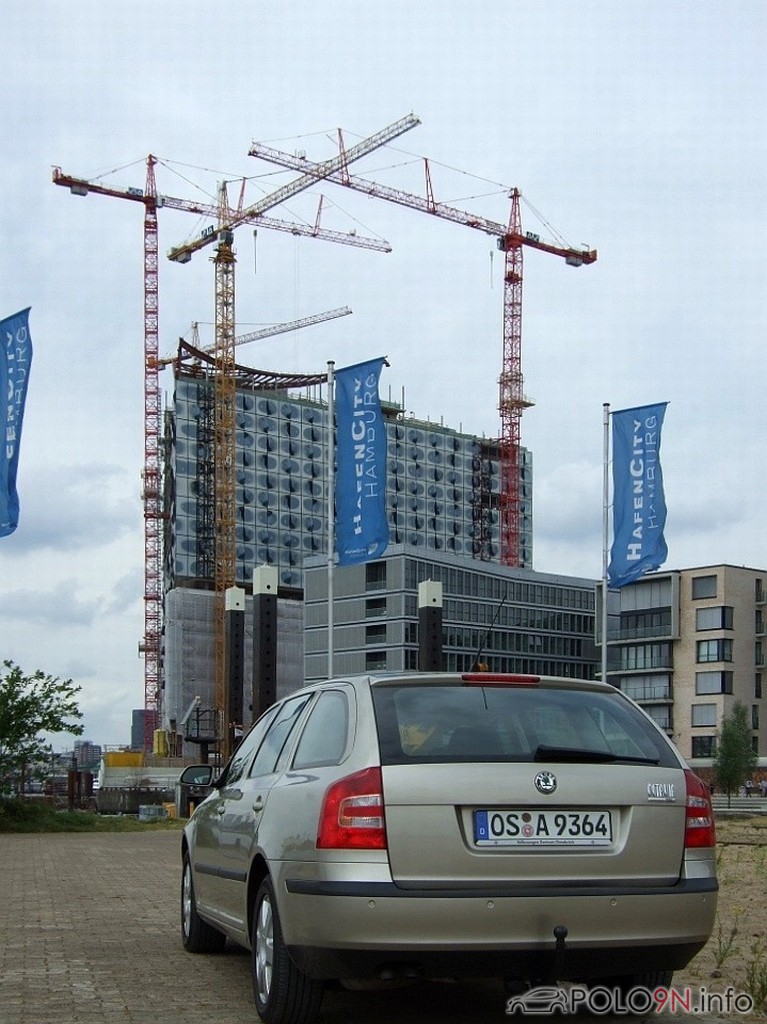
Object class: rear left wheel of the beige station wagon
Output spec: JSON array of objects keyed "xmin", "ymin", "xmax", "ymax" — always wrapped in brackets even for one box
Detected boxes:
[{"xmin": 251, "ymin": 878, "xmax": 325, "ymax": 1024}]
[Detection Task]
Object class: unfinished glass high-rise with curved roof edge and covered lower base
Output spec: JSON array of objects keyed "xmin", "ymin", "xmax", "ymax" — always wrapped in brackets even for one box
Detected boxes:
[{"xmin": 162, "ymin": 345, "xmax": 548, "ymax": 753}]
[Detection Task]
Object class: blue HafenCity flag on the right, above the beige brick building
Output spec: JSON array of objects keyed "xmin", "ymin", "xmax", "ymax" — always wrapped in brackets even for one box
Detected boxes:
[{"xmin": 607, "ymin": 402, "xmax": 669, "ymax": 588}]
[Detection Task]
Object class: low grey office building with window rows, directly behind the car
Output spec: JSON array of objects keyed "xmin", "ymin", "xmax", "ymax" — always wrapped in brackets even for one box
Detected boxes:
[{"xmin": 305, "ymin": 546, "xmax": 597, "ymax": 680}]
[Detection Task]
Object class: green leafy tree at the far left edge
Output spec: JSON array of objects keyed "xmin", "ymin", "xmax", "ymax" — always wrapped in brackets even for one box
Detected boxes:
[{"xmin": 0, "ymin": 662, "xmax": 83, "ymax": 793}]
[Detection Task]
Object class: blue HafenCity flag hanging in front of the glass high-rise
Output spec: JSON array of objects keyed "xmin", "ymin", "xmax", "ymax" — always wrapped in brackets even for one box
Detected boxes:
[{"xmin": 335, "ymin": 358, "xmax": 389, "ymax": 565}]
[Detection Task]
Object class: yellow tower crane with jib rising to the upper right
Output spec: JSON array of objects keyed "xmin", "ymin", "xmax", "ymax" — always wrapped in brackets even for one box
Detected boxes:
[{"xmin": 168, "ymin": 114, "xmax": 420, "ymax": 759}]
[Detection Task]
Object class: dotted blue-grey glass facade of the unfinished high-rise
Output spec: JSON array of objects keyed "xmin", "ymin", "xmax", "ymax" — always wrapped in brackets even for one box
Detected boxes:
[{"xmin": 166, "ymin": 376, "xmax": 532, "ymax": 589}]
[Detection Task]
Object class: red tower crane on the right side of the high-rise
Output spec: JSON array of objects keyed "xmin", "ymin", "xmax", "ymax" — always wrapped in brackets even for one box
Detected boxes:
[{"xmin": 249, "ymin": 142, "xmax": 597, "ymax": 566}]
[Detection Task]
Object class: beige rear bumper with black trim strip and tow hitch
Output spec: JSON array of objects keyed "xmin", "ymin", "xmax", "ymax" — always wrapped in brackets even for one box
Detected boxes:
[{"xmin": 280, "ymin": 879, "xmax": 717, "ymax": 980}]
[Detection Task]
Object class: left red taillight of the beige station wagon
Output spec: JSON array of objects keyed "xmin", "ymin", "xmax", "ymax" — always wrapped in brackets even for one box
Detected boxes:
[{"xmin": 316, "ymin": 768, "xmax": 386, "ymax": 850}]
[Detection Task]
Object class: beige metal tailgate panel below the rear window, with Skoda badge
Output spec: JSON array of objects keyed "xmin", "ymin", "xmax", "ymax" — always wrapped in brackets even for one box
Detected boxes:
[{"xmin": 382, "ymin": 762, "xmax": 686, "ymax": 888}]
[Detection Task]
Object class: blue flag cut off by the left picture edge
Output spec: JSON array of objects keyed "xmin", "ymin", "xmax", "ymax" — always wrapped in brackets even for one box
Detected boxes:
[{"xmin": 0, "ymin": 308, "xmax": 32, "ymax": 537}]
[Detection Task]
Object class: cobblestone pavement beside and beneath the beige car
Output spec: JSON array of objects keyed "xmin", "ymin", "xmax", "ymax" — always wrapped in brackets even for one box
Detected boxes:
[{"xmin": 0, "ymin": 831, "xmax": 749, "ymax": 1024}]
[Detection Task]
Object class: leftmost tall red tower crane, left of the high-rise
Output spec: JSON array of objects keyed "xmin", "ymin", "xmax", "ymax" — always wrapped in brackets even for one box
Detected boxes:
[{"xmin": 52, "ymin": 154, "xmax": 391, "ymax": 750}]
